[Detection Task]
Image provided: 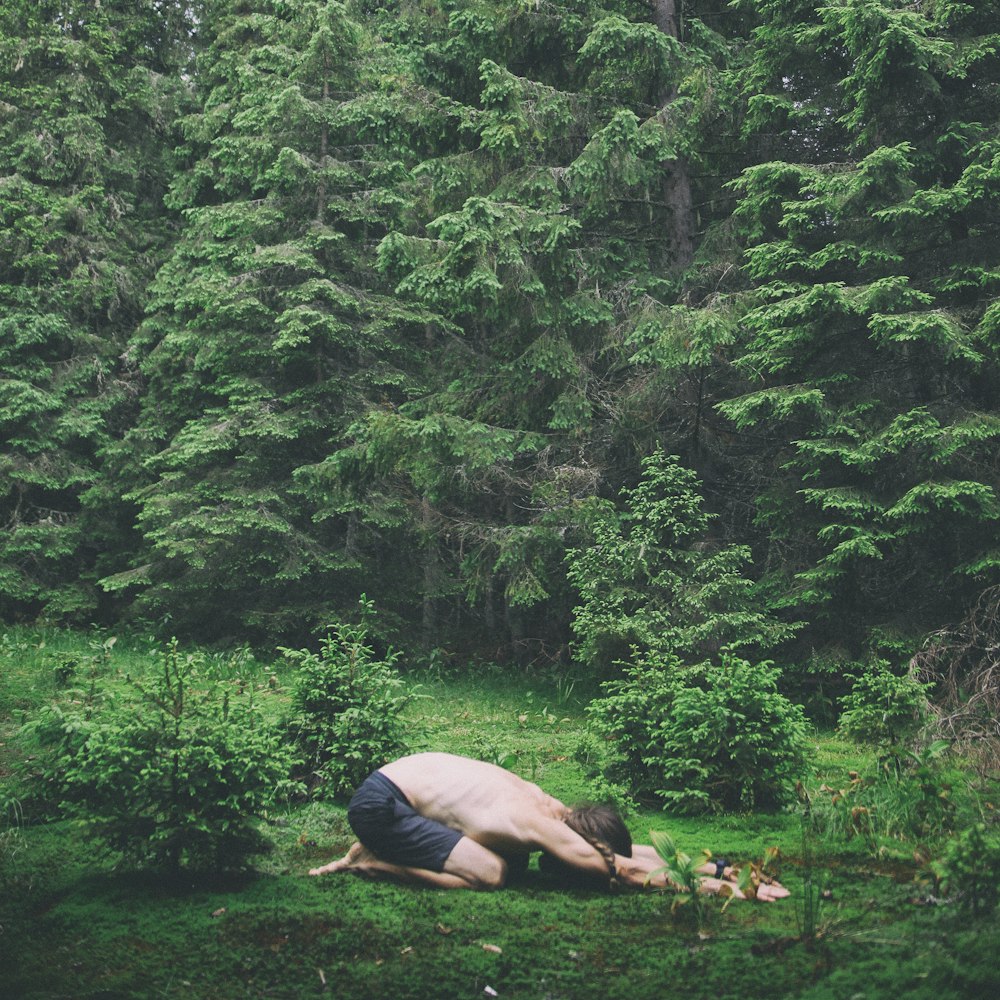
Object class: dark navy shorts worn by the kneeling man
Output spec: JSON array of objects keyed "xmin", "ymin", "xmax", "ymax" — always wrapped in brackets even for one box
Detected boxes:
[{"xmin": 347, "ymin": 771, "xmax": 462, "ymax": 872}]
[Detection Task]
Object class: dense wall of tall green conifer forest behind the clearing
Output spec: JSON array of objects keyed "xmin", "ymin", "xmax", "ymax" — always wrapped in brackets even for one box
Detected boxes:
[{"xmin": 0, "ymin": 0, "xmax": 1000, "ymax": 699}]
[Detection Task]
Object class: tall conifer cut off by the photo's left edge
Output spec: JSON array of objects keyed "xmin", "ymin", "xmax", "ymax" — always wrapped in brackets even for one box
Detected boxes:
[{"xmin": 0, "ymin": 0, "xmax": 189, "ymax": 620}]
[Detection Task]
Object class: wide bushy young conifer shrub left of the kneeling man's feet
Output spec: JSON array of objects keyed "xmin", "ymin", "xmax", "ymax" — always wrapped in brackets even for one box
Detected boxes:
[{"xmin": 27, "ymin": 641, "xmax": 294, "ymax": 870}]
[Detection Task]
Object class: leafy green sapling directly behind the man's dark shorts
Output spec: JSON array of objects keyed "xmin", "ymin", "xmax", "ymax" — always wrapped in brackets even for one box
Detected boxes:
[{"xmin": 282, "ymin": 595, "xmax": 414, "ymax": 797}]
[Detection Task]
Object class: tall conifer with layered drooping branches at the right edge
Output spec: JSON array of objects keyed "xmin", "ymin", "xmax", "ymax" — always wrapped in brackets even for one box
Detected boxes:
[{"xmin": 724, "ymin": 0, "xmax": 1000, "ymax": 645}]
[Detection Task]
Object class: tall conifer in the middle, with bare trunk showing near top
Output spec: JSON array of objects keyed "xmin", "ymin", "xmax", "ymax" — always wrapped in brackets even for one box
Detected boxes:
[{"xmin": 316, "ymin": 3, "xmax": 748, "ymax": 651}]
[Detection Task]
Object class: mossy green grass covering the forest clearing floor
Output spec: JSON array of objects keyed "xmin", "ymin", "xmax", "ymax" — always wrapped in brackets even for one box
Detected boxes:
[{"xmin": 0, "ymin": 632, "xmax": 1000, "ymax": 1000}]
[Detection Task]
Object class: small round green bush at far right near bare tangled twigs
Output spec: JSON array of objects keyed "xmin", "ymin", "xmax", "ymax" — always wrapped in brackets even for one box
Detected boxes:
[{"xmin": 840, "ymin": 660, "xmax": 931, "ymax": 747}]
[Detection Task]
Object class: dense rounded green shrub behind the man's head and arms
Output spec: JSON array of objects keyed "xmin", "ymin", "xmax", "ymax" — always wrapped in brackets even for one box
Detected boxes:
[{"xmin": 588, "ymin": 653, "xmax": 807, "ymax": 812}]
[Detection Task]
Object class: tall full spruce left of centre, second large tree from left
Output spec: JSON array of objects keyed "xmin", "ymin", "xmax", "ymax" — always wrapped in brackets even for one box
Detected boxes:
[{"xmin": 103, "ymin": 0, "xmax": 424, "ymax": 636}]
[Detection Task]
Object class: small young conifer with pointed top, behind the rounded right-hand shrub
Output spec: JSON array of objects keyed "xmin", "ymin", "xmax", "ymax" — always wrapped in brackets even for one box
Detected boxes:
[{"xmin": 567, "ymin": 451, "xmax": 794, "ymax": 677}]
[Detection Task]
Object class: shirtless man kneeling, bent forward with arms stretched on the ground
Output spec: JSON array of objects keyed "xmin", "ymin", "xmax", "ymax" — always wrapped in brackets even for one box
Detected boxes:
[{"xmin": 309, "ymin": 753, "xmax": 788, "ymax": 901}]
